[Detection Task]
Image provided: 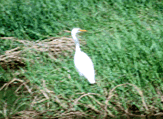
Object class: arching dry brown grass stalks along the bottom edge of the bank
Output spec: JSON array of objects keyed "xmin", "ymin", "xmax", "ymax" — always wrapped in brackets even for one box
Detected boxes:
[{"xmin": 0, "ymin": 78, "xmax": 163, "ymax": 118}]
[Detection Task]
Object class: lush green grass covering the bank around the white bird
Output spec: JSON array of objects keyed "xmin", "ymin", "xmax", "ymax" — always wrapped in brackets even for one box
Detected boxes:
[{"xmin": 0, "ymin": 0, "xmax": 163, "ymax": 116}]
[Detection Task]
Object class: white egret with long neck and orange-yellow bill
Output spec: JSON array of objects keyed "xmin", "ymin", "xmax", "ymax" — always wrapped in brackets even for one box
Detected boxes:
[{"xmin": 71, "ymin": 28, "xmax": 95, "ymax": 84}]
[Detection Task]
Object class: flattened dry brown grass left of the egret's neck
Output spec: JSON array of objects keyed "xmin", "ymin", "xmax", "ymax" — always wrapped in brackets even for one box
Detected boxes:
[{"xmin": 0, "ymin": 37, "xmax": 85, "ymax": 70}]
